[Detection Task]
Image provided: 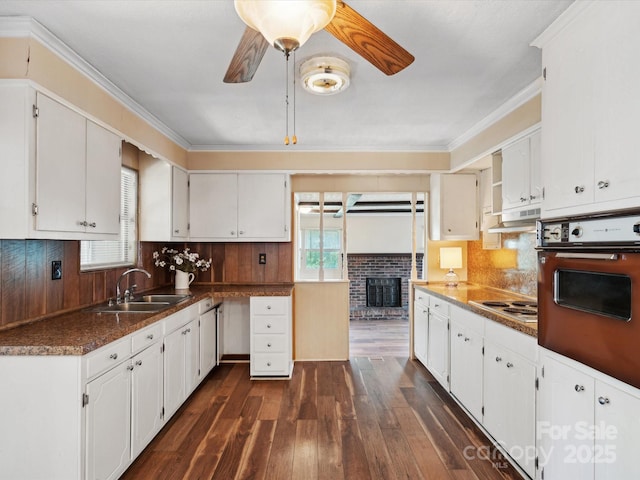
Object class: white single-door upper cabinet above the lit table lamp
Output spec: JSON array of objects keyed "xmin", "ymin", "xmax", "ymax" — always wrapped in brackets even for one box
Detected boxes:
[{"xmin": 429, "ymin": 173, "xmax": 479, "ymax": 240}]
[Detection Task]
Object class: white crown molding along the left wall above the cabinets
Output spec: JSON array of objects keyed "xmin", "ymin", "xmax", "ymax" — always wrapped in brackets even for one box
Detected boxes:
[{"xmin": 0, "ymin": 16, "xmax": 191, "ymax": 150}]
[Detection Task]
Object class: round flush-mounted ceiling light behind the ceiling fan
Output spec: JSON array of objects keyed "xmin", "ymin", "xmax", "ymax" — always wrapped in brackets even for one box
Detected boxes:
[{"xmin": 300, "ymin": 57, "xmax": 351, "ymax": 95}]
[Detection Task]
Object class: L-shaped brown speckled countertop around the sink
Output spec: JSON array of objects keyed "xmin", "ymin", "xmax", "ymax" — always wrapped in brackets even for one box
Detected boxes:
[{"xmin": 0, "ymin": 284, "xmax": 293, "ymax": 355}]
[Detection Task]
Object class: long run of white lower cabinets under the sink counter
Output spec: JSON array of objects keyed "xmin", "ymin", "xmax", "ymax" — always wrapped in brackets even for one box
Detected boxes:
[{"xmin": 0, "ymin": 294, "xmax": 215, "ymax": 480}]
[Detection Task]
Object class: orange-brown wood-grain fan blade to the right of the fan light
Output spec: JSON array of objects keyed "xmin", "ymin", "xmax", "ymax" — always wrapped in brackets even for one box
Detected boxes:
[{"xmin": 324, "ymin": 0, "xmax": 415, "ymax": 75}]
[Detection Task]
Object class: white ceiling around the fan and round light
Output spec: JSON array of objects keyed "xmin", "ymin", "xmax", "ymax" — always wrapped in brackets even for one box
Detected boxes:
[{"xmin": 0, "ymin": 0, "xmax": 572, "ymax": 151}]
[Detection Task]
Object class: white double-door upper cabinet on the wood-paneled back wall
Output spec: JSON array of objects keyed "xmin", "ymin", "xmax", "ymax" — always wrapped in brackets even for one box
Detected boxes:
[{"xmin": 189, "ymin": 173, "xmax": 291, "ymax": 241}]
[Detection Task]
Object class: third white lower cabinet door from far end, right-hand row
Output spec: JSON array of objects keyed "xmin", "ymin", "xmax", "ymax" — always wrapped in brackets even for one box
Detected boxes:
[{"xmin": 450, "ymin": 318, "xmax": 483, "ymax": 420}]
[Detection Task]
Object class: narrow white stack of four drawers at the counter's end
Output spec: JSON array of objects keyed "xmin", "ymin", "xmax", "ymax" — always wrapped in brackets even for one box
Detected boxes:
[{"xmin": 249, "ymin": 296, "xmax": 293, "ymax": 377}]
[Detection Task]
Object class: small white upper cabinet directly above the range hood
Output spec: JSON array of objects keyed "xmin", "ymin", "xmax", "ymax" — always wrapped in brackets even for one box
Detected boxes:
[{"xmin": 502, "ymin": 131, "xmax": 542, "ymax": 212}]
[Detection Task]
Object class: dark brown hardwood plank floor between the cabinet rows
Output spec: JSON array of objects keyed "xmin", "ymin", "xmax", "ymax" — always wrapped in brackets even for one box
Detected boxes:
[{"xmin": 122, "ymin": 318, "xmax": 521, "ymax": 480}]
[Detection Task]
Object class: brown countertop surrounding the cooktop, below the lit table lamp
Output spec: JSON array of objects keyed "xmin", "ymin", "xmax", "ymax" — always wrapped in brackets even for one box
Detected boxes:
[{"xmin": 412, "ymin": 282, "xmax": 538, "ymax": 338}]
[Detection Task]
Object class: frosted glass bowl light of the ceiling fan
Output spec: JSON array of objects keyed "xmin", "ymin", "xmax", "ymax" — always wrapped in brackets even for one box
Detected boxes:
[{"xmin": 234, "ymin": 0, "xmax": 336, "ymax": 53}]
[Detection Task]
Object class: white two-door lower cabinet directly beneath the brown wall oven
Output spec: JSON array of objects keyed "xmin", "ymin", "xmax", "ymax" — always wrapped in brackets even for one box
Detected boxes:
[{"xmin": 537, "ymin": 349, "xmax": 640, "ymax": 480}]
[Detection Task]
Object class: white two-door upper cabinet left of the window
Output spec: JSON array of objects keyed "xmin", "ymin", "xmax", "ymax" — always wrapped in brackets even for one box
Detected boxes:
[{"xmin": 0, "ymin": 82, "xmax": 122, "ymax": 240}]
